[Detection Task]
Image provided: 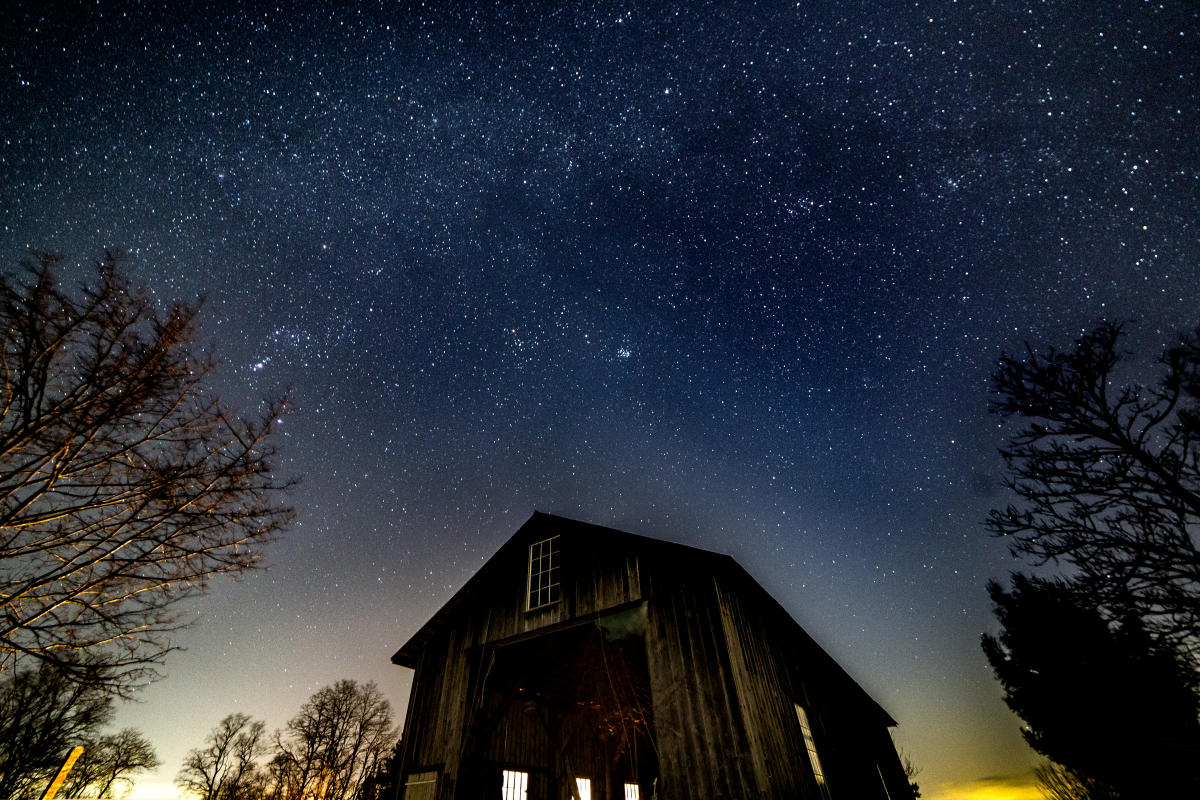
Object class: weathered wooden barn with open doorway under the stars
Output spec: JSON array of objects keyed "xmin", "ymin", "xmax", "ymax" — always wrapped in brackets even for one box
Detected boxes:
[{"xmin": 392, "ymin": 513, "xmax": 912, "ymax": 800}]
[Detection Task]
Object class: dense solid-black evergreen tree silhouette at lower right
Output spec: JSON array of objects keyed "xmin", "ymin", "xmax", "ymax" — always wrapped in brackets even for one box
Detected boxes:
[{"xmin": 983, "ymin": 573, "xmax": 1200, "ymax": 798}]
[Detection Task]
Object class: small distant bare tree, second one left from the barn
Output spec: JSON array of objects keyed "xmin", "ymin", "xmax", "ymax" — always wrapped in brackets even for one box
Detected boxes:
[{"xmin": 175, "ymin": 714, "xmax": 269, "ymax": 800}]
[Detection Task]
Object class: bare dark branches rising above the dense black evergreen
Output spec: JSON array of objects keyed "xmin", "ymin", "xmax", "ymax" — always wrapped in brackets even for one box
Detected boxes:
[{"xmin": 988, "ymin": 324, "xmax": 1200, "ymax": 663}]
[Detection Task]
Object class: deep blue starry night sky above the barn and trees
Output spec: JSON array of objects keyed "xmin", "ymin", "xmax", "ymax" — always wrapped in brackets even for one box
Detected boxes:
[{"xmin": 0, "ymin": 0, "xmax": 1200, "ymax": 800}]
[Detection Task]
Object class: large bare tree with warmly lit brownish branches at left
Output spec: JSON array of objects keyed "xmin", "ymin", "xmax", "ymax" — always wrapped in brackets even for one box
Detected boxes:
[{"xmin": 0, "ymin": 255, "xmax": 289, "ymax": 692}]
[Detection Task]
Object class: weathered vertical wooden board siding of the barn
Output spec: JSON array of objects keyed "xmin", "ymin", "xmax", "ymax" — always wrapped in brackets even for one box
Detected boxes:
[{"xmin": 396, "ymin": 515, "xmax": 911, "ymax": 800}]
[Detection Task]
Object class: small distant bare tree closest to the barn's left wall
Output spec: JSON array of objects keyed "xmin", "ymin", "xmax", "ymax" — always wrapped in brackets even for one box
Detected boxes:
[{"xmin": 271, "ymin": 680, "xmax": 398, "ymax": 800}]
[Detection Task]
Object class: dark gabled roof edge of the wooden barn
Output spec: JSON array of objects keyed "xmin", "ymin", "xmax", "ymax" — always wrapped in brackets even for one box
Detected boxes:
[{"xmin": 391, "ymin": 511, "xmax": 896, "ymax": 726}]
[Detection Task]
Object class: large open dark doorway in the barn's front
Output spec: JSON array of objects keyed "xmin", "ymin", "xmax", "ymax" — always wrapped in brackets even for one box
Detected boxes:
[{"xmin": 457, "ymin": 609, "xmax": 658, "ymax": 800}]
